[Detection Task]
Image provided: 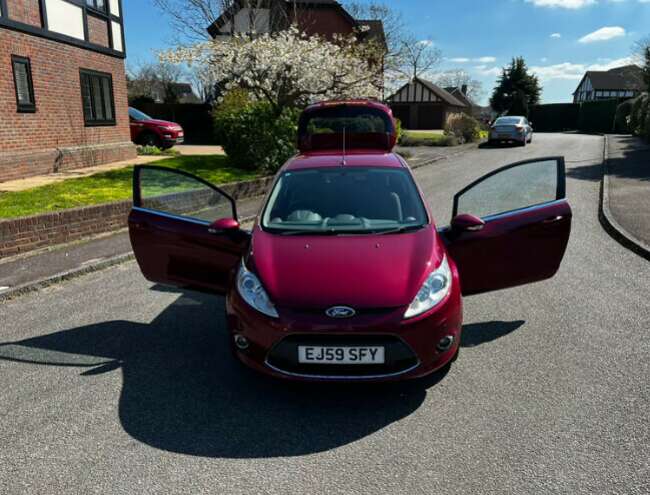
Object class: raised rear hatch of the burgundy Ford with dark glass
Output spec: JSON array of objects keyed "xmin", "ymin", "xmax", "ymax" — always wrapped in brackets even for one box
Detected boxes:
[{"xmin": 298, "ymin": 100, "xmax": 397, "ymax": 151}]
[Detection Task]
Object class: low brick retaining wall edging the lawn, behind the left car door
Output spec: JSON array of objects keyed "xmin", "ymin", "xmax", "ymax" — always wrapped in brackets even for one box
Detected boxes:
[{"xmin": 0, "ymin": 177, "xmax": 273, "ymax": 259}]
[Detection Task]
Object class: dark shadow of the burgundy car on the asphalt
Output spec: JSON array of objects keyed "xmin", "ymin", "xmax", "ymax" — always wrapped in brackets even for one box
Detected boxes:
[{"xmin": 0, "ymin": 292, "xmax": 523, "ymax": 458}]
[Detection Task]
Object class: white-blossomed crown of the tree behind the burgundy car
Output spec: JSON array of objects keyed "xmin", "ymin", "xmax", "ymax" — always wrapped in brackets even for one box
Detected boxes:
[{"xmin": 161, "ymin": 27, "xmax": 383, "ymax": 114}]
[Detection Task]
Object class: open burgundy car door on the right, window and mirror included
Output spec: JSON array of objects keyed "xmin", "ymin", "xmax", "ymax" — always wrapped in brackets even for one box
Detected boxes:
[{"xmin": 442, "ymin": 157, "xmax": 571, "ymax": 295}]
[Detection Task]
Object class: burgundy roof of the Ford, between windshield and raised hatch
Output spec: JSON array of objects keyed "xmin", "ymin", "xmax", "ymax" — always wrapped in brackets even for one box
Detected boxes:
[{"xmin": 283, "ymin": 150, "xmax": 405, "ymax": 171}]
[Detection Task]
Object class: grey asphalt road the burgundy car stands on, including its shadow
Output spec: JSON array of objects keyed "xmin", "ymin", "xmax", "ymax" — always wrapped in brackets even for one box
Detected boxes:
[{"xmin": 0, "ymin": 134, "xmax": 650, "ymax": 494}]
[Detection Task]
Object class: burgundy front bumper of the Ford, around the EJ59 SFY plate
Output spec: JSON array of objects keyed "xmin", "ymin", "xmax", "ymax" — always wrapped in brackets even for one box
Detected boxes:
[{"xmin": 226, "ymin": 278, "xmax": 462, "ymax": 381}]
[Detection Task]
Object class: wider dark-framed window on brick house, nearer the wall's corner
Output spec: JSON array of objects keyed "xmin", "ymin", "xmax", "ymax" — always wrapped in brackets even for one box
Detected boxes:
[{"xmin": 80, "ymin": 69, "xmax": 115, "ymax": 126}]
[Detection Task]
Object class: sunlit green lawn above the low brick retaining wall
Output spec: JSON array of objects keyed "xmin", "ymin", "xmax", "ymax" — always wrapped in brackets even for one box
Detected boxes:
[{"xmin": 0, "ymin": 155, "xmax": 259, "ymax": 218}]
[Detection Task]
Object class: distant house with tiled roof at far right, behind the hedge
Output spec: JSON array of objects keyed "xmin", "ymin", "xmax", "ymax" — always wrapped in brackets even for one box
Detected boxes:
[{"xmin": 573, "ymin": 65, "xmax": 645, "ymax": 103}]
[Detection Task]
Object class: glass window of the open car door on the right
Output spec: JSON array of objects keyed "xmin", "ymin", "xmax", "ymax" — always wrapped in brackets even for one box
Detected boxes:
[{"xmin": 454, "ymin": 158, "xmax": 565, "ymax": 217}]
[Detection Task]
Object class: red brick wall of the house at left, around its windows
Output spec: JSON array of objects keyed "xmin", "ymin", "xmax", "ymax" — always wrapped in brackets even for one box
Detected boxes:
[{"xmin": 0, "ymin": 27, "xmax": 135, "ymax": 181}]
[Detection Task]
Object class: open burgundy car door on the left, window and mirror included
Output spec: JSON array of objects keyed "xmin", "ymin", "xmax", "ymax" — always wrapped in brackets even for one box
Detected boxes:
[{"xmin": 129, "ymin": 165, "xmax": 250, "ymax": 294}]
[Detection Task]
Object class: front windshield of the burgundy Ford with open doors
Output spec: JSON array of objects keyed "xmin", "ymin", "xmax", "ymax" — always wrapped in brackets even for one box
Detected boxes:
[{"xmin": 262, "ymin": 166, "xmax": 428, "ymax": 235}]
